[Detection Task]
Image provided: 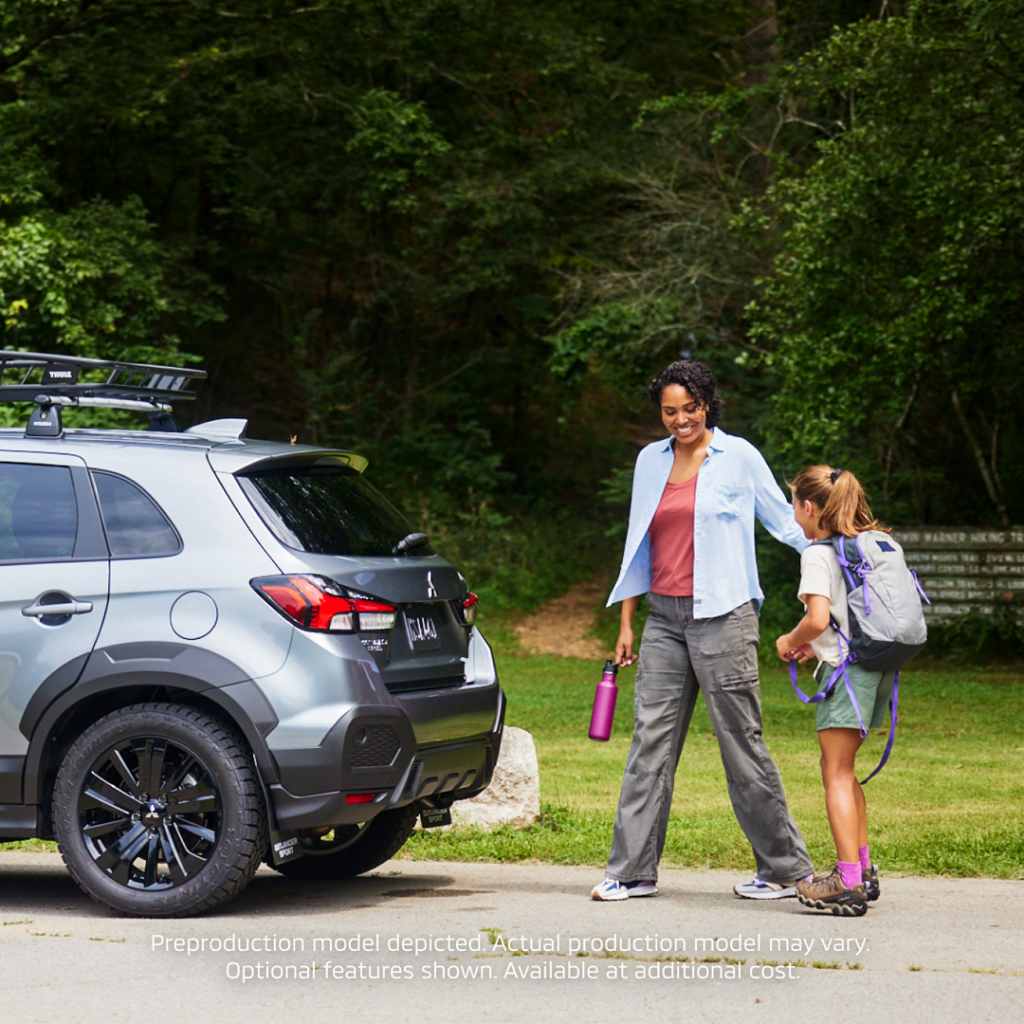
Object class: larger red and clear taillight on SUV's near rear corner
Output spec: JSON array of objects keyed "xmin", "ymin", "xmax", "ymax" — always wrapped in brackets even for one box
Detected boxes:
[{"xmin": 251, "ymin": 575, "xmax": 395, "ymax": 633}]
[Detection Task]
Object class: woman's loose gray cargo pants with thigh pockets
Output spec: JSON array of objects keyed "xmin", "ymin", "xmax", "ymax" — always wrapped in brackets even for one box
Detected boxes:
[{"xmin": 607, "ymin": 594, "xmax": 812, "ymax": 882}]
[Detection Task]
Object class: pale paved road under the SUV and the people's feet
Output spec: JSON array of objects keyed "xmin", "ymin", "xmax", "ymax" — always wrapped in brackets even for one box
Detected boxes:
[{"xmin": 0, "ymin": 852, "xmax": 1024, "ymax": 1024}]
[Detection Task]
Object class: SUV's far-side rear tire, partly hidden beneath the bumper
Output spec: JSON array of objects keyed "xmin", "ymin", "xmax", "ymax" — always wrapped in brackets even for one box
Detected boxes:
[{"xmin": 276, "ymin": 804, "xmax": 419, "ymax": 881}]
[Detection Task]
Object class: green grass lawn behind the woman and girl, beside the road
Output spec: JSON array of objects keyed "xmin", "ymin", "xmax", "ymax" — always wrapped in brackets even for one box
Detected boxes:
[{"xmin": 402, "ymin": 645, "xmax": 1024, "ymax": 878}]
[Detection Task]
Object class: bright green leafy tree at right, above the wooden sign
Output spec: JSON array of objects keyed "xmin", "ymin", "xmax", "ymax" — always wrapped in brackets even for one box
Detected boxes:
[{"xmin": 752, "ymin": 0, "xmax": 1024, "ymax": 525}]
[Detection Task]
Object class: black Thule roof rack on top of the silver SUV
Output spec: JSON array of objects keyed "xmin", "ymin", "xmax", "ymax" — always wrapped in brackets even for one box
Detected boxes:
[{"xmin": 0, "ymin": 351, "xmax": 206, "ymax": 437}]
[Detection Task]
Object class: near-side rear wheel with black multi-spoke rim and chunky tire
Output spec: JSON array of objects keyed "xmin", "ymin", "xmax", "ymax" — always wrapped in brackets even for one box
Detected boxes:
[{"xmin": 53, "ymin": 703, "xmax": 268, "ymax": 918}]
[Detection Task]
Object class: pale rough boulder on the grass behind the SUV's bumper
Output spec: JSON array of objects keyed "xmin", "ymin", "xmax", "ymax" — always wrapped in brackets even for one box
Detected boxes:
[{"xmin": 452, "ymin": 725, "xmax": 541, "ymax": 828}]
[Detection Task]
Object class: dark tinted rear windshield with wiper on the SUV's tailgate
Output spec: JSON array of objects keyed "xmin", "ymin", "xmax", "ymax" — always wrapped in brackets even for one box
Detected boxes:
[{"xmin": 239, "ymin": 465, "xmax": 433, "ymax": 556}]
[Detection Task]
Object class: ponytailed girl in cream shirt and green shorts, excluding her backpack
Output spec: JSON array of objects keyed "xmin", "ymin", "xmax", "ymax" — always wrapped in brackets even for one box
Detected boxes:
[{"xmin": 775, "ymin": 466, "xmax": 893, "ymax": 918}]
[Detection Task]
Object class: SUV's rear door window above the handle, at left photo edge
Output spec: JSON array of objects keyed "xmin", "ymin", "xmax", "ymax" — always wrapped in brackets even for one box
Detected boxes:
[{"xmin": 0, "ymin": 462, "xmax": 78, "ymax": 561}]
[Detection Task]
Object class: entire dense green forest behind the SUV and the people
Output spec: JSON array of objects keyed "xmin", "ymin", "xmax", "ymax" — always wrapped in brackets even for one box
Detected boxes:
[{"xmin": 0, "ymin": 0, "xmax": 1024, "ymax": 603}]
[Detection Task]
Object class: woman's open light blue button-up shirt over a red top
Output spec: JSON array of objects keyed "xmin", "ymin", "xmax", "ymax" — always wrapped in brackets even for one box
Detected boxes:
[{"xmin": 608, "ymin": 427, "xmax": 811, "ymax": 618}]
